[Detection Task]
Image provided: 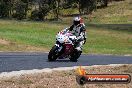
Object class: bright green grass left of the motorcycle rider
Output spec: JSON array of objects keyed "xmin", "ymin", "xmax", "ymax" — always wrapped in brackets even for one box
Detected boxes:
[{"xmin": 0, "ymin": 21, "xmax": 64, "ymax": 47}]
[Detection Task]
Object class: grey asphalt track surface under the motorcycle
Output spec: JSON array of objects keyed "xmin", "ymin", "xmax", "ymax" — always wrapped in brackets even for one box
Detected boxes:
[{"xmin": 0, "ymin": 52, "xmax": 132, "ymax": 73}]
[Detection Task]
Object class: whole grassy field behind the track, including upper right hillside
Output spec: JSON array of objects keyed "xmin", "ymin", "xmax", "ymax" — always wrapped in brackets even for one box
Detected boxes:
[{"xmin": 0, "ymin": 0, "xmax": 132, "ymax": 55}]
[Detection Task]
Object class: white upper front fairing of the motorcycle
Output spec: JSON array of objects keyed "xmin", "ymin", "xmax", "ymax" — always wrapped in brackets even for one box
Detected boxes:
[{"xmin": 56, "ymin": 31, "xmax": 77, "ymax": 44}]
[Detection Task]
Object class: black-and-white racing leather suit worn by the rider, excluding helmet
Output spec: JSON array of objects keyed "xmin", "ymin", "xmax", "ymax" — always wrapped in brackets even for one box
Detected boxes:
[{"xmin": 64, "ymin": 23, "xmax": 86, "ymax": 51}]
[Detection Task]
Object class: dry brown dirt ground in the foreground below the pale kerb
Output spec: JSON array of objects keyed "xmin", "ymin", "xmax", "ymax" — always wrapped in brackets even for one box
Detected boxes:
[{"xmin": 0, "ymin": 64, "xmax": 132, "ymax": 88}]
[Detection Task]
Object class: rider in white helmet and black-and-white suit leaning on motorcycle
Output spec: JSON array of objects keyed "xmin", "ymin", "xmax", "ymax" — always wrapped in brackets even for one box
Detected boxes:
[{"xmin": 64, "ymin": 16, "xmax": 86, "ymax": 52}]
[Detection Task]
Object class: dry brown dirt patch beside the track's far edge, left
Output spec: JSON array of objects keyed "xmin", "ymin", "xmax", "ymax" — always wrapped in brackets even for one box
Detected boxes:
[{"xmin": 0, "ymin": 39, "xmax": 49, "ymax": 52}]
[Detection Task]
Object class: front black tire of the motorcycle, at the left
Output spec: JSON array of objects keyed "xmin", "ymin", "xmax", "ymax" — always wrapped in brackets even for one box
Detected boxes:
[{"xmin": 48, "ymin": 46, "xmax": 58, "ymax": 61}]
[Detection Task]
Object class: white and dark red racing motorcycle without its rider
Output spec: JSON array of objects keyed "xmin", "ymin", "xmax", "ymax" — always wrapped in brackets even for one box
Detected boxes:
[{"xmin": 48, "ymin": 31, "xmax": 82, "ymax": 62}]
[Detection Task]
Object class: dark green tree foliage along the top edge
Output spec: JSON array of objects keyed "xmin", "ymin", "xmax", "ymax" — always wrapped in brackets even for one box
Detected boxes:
[{"xmin": 0, "ymin": 0, "xmax": 108, "ymax": 20}]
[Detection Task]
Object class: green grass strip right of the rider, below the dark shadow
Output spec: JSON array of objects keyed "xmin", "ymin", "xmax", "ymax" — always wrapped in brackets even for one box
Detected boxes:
[{"xmin": 84, "ymin": 27, "xmax": 132, "ymax": 55}]
